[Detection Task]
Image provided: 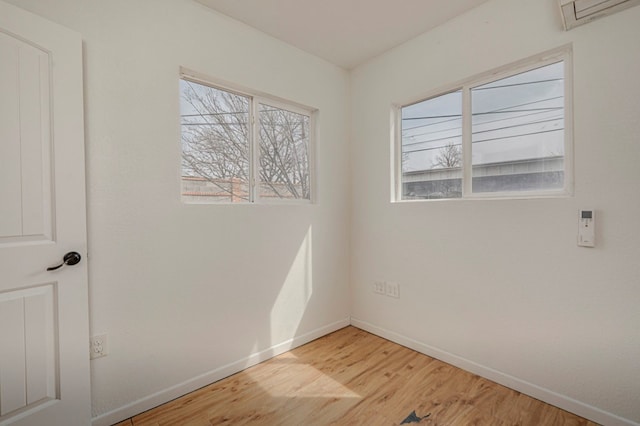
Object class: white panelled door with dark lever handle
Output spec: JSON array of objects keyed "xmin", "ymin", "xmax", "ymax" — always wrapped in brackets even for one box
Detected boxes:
[{"xmin": 0, "ymin": 1, "xmax": 91, "ymax": 426}]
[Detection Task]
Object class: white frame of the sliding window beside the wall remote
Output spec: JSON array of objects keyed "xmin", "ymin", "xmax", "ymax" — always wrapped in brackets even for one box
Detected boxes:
[{"xmin": 391, "ymin": 45, "xmax": 574, "ymax": 203}]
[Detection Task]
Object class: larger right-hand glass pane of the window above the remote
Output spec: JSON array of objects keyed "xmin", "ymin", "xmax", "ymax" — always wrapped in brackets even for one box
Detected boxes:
[{"xmin": 471, "ymin": 62, "xmax": 564, "ymax": 193}]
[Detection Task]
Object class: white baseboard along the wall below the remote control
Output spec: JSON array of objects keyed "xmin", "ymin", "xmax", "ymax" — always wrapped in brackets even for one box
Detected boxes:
[{"xmin": 351, "ymin": 317, "xmax": 640, "ymax": 426}]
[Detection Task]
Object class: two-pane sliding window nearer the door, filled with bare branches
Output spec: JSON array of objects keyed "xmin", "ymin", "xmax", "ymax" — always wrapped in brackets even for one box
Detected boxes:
[{"xmin": 180, "ymin": 70, "xmax": 313, "ymax": 203}]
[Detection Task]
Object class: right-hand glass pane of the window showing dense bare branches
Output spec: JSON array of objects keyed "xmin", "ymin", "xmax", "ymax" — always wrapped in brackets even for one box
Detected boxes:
[{"xmin": 258, "ymin": 104, "xmax": 310, "ymax": 200}]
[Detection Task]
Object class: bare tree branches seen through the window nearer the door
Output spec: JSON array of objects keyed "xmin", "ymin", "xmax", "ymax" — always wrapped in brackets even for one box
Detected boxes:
[{"xmin": 182, "ymin": 82, "xmax": 309, "ymax": 198}]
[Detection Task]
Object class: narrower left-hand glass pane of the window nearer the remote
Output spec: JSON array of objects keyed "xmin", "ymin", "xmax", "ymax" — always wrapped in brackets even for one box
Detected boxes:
[{"xmin": 402, "ymin": 91, "xmax": 462, "ymax": 200}]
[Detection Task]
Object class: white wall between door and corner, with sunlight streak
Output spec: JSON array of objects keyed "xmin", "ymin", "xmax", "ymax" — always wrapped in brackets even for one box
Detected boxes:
[{"xmin": 3, "ymin": 0, "xmax": 349, "ymax": 423}]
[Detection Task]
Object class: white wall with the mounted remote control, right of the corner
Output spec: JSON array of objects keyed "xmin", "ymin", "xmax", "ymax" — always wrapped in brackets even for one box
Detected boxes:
[{"xmin": 351, "ymin": 0, "xmax": 640, "ymax": 424}]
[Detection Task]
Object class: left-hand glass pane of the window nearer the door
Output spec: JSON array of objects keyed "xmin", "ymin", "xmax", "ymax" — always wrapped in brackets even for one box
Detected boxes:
[{"xmin": 180, "ymin": 80, "xmax": 250, "ymax": 203}]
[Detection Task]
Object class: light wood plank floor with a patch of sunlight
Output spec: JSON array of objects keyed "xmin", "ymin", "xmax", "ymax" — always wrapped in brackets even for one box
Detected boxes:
[{"xmin": 112, "ymin": 327, "xmax": 595, "ymax": 426}]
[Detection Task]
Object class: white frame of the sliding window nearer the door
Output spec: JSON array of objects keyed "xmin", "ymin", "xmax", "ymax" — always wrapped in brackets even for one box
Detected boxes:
[{"xmin": 179, "ymin": 67, "xmax": 318, "ymax": 205}]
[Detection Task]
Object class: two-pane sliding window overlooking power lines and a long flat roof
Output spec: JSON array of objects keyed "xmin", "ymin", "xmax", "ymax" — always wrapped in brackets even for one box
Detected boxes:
[{"xmin": 396, "ymin": 49, "xmax": 572, "ymax": 200}]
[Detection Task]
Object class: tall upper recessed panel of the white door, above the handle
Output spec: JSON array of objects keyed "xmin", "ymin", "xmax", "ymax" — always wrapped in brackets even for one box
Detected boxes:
[{"xmin": 0, "ymin": 33, "xmax": 52, "ymax": 244}]
